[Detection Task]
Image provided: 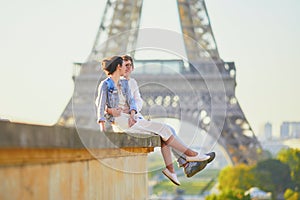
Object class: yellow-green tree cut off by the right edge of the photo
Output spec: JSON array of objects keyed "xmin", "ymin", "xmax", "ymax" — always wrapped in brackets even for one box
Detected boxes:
[{"xmin": 277, "ymin": 148, "xmax": 300, "ymax": 188}]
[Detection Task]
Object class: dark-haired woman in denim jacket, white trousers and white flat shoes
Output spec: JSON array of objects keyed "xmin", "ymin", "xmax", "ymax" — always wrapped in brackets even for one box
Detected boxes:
[{"xmin": 96, "ymin": 56, "xmax": 210, "ymax": 185}]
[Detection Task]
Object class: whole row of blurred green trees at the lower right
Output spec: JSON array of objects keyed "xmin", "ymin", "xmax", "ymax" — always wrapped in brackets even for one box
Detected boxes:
[{"xmin": 206, "ymin": 148, "xmax": 300, "ymax": 200}]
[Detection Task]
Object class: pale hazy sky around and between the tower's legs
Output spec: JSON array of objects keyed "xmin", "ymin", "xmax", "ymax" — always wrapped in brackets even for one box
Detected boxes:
[{"xmin": 0, "ymin": 0, "xmax": 300, "ymax": 137}]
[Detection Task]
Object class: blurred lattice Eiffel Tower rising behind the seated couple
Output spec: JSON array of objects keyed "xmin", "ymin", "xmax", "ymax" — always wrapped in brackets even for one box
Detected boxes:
[{"xmin": 58, "ymin": 0, "xmax": 261, "ymax": 164}]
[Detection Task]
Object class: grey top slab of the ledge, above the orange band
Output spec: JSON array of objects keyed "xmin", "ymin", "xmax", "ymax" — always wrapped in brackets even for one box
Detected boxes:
[{"xmin": 0, "ymin": 121, "xmax": 160, "ymax": 149}]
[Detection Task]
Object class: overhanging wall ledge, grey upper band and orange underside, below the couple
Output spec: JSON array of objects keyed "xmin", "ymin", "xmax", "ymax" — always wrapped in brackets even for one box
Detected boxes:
[{"xmin": 0, "ymin": 121, "xmax": 160, "ymax": 165}]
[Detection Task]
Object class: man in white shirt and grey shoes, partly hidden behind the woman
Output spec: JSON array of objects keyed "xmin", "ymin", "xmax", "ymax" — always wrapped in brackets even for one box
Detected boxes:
[{"xmin": 122, "ymin": 55, "xmax": 216, "ymax": 178}]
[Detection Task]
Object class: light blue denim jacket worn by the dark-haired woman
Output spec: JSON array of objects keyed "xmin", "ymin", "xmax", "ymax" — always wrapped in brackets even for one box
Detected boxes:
[{"xmin": 95, "ymin": 77, "xmax": 137, "ymax": 122}]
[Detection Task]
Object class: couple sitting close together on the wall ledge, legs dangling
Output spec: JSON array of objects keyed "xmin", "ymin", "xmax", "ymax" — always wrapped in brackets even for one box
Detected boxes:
[{"xmin": 95, "ymin": 56, "xmax": 215, "ymax": 185}]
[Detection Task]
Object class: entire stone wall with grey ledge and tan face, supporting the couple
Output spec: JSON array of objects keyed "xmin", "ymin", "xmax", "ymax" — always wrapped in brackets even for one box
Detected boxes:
[{"xmin": 0, "ymin": 121, "xmax": 160, "ymax": 200}]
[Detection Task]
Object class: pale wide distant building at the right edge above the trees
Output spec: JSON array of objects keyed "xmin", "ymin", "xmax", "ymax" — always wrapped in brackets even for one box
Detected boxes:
[{"xmin": 280, "ymin": 122, "xmax": 300, "ymax": 139}]
